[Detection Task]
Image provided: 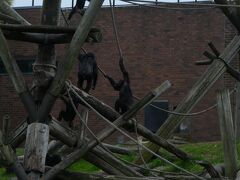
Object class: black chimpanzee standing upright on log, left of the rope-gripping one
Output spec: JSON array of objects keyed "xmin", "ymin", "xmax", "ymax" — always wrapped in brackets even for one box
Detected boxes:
[{"xmin": 78, "ymin": 52, "xmax": 98, "ymax": 92}]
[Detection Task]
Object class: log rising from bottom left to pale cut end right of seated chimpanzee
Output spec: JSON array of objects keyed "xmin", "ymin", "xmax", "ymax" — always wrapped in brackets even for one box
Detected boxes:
[{"xmin": 45, "ymin": 81, "xmax": 170, "ymax": 180}]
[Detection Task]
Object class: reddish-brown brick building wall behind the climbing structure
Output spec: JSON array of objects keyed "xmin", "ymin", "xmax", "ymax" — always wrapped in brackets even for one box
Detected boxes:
[{"xmin": 0, "ymin": 6, "xmax": 235, "ymax": 141}]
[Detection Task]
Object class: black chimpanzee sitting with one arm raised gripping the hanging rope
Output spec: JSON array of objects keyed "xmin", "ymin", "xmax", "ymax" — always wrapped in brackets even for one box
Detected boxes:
[{"xmin": 105, "ymin": 58, "xmax": 133, "ymax": 114}]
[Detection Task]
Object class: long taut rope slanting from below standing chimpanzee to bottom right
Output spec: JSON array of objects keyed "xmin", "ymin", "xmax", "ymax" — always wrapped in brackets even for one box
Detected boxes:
[{"xmin": 66, "ymin": 82, "xmax": 206, "ymax": 180}]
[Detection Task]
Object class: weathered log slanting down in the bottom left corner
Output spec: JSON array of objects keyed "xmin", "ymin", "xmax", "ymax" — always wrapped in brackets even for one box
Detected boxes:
[{"xmin": 0, "ymin": 131, "xmax": 27, "ymax": 180}]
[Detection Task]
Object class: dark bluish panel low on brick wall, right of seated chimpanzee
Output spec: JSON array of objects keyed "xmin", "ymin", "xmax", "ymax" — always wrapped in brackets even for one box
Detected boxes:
[{"xmin": 144, "ymin": 100, "xmax": 168, "ymax": 133}]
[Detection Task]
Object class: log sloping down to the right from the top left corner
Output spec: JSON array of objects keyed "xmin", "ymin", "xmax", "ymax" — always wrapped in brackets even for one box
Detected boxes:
[{"xmin": 0, "ymin": 1, "xmax": 30, "ymax": 25}]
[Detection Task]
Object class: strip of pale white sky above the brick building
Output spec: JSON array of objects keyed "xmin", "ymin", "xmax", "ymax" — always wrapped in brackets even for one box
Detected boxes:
[{"xmin": 13, "ymin": 0, "xmax": 197, "ymax": 7}]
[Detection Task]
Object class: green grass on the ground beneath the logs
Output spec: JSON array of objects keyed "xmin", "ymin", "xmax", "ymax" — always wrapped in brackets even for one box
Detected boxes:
[{"xmin": 0, "ymin": 142, "xmax": 240, "ymax": 180}]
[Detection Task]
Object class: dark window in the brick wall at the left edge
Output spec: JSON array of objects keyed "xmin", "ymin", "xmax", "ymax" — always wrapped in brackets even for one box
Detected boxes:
[{"xmin": 0, "ymin": 59, "xmax": 35, "ymax": 74}]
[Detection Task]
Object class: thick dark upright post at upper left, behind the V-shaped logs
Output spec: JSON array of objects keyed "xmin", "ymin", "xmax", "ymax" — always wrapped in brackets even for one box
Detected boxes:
[{"xmin": 33, "ymin": 0, "xmax": 61, "ymax": 115}]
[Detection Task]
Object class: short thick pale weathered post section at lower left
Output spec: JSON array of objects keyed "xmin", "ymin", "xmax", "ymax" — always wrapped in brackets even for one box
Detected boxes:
[{"xmin": 24, "ymin": 123, "xmax": 49, "ymax": 176}]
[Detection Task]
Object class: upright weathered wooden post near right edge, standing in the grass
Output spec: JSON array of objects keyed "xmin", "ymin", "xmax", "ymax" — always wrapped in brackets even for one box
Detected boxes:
[{"xmin": 217, "ymin": 89, "xmax": 237, "ymax": 179}]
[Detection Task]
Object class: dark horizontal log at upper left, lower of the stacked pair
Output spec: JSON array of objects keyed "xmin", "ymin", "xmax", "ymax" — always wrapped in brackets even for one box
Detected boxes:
[{"xmin": 3, "ymin": 29, "xmax": 102, "ymax": 44}]
